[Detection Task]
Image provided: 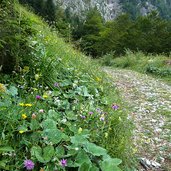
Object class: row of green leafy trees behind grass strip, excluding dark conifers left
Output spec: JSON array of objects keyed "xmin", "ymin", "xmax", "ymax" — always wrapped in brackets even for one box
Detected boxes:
[{"xmin": 78, "ymin": 12, "xmax": 171, "ymax": 56}]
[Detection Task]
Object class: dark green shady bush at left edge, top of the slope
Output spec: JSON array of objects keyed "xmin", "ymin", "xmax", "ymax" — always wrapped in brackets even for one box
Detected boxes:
[{"xmin": 0, "ymin": 1, "xmax": 35, "ymax": 73}]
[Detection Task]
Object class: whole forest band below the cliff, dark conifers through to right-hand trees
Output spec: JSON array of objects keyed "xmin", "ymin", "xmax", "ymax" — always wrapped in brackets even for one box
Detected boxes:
[{"xmin": 20, "ymin": 0, "xmax": 171, "ymax": 57}]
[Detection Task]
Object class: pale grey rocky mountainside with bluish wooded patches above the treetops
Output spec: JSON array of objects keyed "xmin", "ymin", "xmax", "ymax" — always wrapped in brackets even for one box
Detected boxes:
[{"xmin": 56, "ymin": 0, "xmax": 171, "ymax": 20}]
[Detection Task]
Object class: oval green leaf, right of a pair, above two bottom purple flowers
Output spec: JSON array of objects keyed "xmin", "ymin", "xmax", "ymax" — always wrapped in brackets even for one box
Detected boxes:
[{"xmin": 43, "ymin": 145, "xmax": 55, "ymax": 162}]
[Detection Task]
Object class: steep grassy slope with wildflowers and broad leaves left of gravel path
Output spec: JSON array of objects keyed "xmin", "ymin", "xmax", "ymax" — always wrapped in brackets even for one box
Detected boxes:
[{"xmin": 0, "ymin": 1, "xmax": 132, "ymax": 171}]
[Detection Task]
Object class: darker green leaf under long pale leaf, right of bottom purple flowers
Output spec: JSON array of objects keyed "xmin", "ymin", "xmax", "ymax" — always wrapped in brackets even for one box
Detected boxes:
[{"xmin": 75, "ymin": 150, "xmax": 91, "ymax": 166}]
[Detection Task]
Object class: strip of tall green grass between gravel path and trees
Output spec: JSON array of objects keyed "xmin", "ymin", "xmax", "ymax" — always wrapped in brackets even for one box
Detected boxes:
[{"xmin": 100, "ymin": 51, "xmax": 171, "ymax": 84}]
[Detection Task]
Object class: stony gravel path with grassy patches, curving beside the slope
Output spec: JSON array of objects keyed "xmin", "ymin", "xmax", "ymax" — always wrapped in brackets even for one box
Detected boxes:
[{"xmin": 104, "ymin": 68, "xmax": 171, "ymax": 171}]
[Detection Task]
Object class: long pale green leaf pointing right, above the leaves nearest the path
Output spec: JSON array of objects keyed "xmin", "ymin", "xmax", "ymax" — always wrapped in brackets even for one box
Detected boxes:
[{"xmin": 85, "ymin": 142, "xmax": 107, "ymax": 156}]
